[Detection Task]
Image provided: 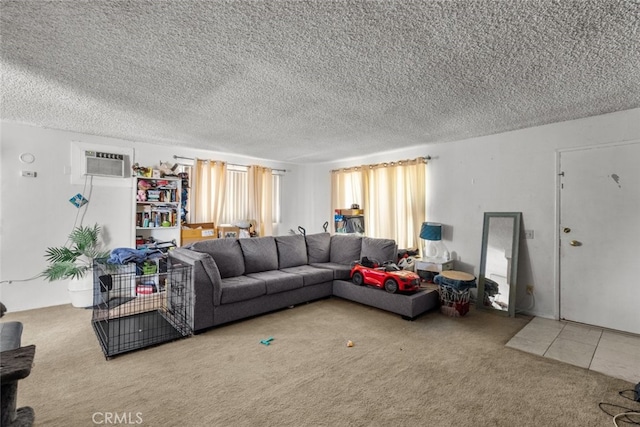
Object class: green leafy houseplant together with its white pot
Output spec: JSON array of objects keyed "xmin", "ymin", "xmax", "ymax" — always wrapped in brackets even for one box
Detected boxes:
[{"xmin": 41, "ymin": 224, "xmax": 110, "ymax": 307}]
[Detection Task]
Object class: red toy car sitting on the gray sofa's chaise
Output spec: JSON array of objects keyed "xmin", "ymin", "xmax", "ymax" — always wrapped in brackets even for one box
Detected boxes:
[{"xmin": 351, "ymin": 258, "xmax": 420, "ymax": 294}]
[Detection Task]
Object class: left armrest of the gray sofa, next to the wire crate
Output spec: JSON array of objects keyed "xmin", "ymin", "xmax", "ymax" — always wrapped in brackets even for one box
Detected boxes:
[{"xmin": 169, "ymin": 248, "xmax": 222, "ymax": 331}]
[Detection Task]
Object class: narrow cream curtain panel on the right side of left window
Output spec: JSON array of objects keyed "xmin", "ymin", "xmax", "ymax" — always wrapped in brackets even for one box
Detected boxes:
[{"xmin": 247, "ymin": 165, "xmax": 273, "ymax": 236}]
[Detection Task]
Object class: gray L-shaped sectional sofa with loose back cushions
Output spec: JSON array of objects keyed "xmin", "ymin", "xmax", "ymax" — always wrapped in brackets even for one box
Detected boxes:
[{"xmin": 169, "ymin": 233, "xmax": 438, "ymax": 333}]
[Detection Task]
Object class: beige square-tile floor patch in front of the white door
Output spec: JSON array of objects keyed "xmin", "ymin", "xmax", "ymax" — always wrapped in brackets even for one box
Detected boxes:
[{"xmin": 507, "ymin": 317, "xmax": 640, "ymax": 384}]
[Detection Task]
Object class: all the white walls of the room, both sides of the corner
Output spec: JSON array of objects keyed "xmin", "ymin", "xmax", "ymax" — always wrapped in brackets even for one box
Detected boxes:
[{"xmin": 0, "ymin": 109, "xmax": 640, "ymax": 317}]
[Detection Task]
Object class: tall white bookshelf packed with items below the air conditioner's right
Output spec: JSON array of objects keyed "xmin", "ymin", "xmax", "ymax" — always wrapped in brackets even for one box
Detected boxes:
[{"xmin": 134, "ymin": 177, "xmax": 182, "ymax": 249}]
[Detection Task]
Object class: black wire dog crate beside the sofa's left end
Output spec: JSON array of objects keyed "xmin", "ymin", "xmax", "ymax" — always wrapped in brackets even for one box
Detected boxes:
[{"xmin": 92, "ymin": 257, "xmax": 193, "ymax": 359}]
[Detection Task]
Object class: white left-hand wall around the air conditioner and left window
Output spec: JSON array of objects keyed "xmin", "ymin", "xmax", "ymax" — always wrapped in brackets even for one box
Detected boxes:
[{"xmin": 0, "ymin": 122, "xmax": 304, "ymax": 311}]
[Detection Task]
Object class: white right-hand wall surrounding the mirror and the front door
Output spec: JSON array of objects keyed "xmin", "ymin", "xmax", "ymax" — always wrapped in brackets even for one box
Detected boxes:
[{"xmin": 309, "ymin": 109, "xmax": 640, "ymax": 318}]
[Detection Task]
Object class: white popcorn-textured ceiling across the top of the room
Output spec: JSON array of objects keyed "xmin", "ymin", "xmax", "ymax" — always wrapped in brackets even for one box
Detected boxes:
[{"xmin": 0, "ymin": 0, "xmax": 640, "ymax": 163}]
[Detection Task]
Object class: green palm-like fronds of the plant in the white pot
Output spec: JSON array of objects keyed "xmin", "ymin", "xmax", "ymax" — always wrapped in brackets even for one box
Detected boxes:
[{"xmin": 41, "ymin": 224, "xmax": 110, "ymax": 282}]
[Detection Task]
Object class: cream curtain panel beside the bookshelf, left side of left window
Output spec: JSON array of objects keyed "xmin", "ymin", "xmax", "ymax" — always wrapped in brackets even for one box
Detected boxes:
[{"xmin": 189, "ymin": 159, "xmax": 227, "ymax": 227}]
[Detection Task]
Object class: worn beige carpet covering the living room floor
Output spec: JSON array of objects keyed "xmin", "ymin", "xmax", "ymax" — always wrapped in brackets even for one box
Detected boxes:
[{"xmin": 3, "ymin": 298, "xmax": 634, "ymax": 426}]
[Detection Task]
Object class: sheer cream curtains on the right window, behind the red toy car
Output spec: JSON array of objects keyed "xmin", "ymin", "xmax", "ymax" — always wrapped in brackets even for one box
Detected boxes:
[{"xmin": 331, "ymin": 157, "xmax": 426, "ymax": 248}]
